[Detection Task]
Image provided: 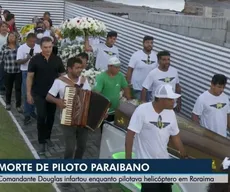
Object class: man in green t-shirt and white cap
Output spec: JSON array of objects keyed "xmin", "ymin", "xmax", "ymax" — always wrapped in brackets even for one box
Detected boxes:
[{"xmin": 93, "ymin": 57, "xmax": 131, "ymax": 133}]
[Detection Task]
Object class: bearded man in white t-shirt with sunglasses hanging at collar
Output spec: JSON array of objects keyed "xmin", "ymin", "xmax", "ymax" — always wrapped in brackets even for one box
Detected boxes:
[{"xmin": 126, "ymin": 36, "xmax": 157, "ymax": 101}]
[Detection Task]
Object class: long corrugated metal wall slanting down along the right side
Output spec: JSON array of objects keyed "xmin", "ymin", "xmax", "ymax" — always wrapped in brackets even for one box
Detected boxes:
[{"xmin": 65, "ymin": 2, "xmax": 230, "ymax": 116}]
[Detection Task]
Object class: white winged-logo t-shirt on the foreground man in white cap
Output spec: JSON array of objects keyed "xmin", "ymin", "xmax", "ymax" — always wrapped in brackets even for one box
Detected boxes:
[{"xmin": 128, "ymin": 102, "xmax": 179, "ymax": 159}]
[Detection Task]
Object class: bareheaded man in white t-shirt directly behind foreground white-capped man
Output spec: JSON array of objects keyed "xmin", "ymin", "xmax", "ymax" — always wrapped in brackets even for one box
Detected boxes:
[{"xmin": 141, "ymin": 51, "xmax": 181, "ymax": 112}]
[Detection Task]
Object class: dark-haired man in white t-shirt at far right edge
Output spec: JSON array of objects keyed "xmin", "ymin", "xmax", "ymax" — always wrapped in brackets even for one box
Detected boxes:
[{"xmin": 192, "ymin": 74, "xmax": 230, "ymax": 137}]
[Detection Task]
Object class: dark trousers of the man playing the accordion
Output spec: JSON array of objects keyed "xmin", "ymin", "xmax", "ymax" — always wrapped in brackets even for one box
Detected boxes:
[{"xmin": 61, "ymin": 125, "xmax": 88, "ymax": 159}]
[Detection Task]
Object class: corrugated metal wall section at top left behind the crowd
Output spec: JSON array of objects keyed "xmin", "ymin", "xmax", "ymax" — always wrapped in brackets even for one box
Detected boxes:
[{"xmin": 0, "ymin": 0, "xmax": 65, "ymax": 27}]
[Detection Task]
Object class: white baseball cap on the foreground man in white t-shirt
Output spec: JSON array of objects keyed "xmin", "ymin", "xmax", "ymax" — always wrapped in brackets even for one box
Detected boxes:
[{"xmin": 155, "ymin": 84, "xmax": 181, "ymax": 99}]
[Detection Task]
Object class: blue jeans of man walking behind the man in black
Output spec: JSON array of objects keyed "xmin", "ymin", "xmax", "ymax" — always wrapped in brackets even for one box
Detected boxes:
[{"xmin": 22, "ymin": 71, "xmax": 35, "ymax": 117}]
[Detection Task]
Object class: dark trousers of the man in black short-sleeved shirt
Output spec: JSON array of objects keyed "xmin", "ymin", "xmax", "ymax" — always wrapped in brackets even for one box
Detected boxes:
[{"xmin": 33, "ymin": 95, "xmax": 56, "ymax": 144}]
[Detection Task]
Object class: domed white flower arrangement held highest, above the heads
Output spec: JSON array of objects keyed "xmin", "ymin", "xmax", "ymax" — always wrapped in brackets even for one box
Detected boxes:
[{"xmin": 60, "ymin": 17, "xmax": 106, "ymax": 40}]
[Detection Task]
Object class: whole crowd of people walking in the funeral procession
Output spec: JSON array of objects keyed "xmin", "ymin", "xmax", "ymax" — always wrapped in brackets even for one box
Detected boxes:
[{"xmin": 0, "ymin": 4, "xmax": 230, "ymax": 192}]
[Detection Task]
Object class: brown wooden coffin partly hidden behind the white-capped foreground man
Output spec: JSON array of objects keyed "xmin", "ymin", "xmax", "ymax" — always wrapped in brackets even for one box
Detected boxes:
[{"xmin": 117, "ymin": 102, "xmax": 230, "ymax": 159}]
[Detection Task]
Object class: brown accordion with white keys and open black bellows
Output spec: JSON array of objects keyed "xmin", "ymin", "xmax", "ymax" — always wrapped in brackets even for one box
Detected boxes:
[{"xmin": 61, "ymin": 86, "xmax": 110, "ymax": 131}]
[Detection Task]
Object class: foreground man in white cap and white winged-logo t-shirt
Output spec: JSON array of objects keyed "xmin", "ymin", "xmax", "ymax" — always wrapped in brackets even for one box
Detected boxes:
[{"xmin": 125, "ymin": 84, "xmax": 187, "ymax": 192}]
